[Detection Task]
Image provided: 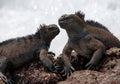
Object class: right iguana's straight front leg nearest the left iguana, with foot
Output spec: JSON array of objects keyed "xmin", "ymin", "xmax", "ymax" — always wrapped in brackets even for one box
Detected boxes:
[{"xmin": 55, "ymin": 43, "xmax": 75, "ymax": 77}]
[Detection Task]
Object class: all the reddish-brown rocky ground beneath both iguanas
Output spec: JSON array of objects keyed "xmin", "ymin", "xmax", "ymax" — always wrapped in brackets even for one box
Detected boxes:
[{"xmin": 0, "ymin": 48, "xmax": 120, "ymax": 84}]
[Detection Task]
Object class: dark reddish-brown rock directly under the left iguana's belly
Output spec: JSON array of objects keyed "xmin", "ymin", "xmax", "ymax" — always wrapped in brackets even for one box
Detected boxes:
[{"xmin": 13, "ymin": 53, "xmax": 62, "ymax": 84}]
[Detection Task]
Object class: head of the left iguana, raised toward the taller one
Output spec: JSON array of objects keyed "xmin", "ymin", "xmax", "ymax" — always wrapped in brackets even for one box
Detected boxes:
[{"xmin": 36, "ymin": 24, "xmax": 60, "ymax": 41}]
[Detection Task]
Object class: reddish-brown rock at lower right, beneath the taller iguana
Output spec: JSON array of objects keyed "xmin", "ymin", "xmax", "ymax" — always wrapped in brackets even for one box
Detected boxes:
[{"xmin": 58, "ymin": 48, "xmax": 120, "ymax": 84}]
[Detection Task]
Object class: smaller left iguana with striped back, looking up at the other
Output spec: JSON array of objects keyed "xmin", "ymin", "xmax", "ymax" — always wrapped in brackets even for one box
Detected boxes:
[{"xmin": 0, "ymin": 24, "xmax": 60, "ymax": 84}]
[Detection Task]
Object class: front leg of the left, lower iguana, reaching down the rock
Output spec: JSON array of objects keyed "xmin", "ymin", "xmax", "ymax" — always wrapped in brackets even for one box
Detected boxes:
[{"xmin": 39, "ymin": 49, "xmax": 56, "ymax": 72}]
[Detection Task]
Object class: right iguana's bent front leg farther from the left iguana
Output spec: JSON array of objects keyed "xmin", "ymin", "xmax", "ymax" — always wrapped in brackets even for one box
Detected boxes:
[{"xmin": 85, "ymin": 38, "xmax": 106, "ymax": 70}]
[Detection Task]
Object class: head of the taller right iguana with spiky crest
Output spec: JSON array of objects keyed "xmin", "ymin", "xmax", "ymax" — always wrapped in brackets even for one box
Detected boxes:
[{"xmin": 58, "ymin": 12, "xmax": 85, "ymax": 29}]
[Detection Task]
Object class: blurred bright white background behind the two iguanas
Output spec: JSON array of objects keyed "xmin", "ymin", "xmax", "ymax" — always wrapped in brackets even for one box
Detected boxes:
[{"xmin": 0, "ymin": 0, "xmax": 120, "ymax": 55}]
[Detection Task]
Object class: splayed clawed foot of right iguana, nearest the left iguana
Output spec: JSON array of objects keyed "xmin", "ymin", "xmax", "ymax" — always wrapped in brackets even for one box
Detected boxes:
[{"xmin": 56, "ymin": 66, "xmax": 75, "ymax": 77}]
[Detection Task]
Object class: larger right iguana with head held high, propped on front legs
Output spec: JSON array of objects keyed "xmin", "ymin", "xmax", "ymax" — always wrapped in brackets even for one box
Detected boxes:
[{"xmin": 58, "ymin": 11, "xmax": 120, "ymax": 76}]
